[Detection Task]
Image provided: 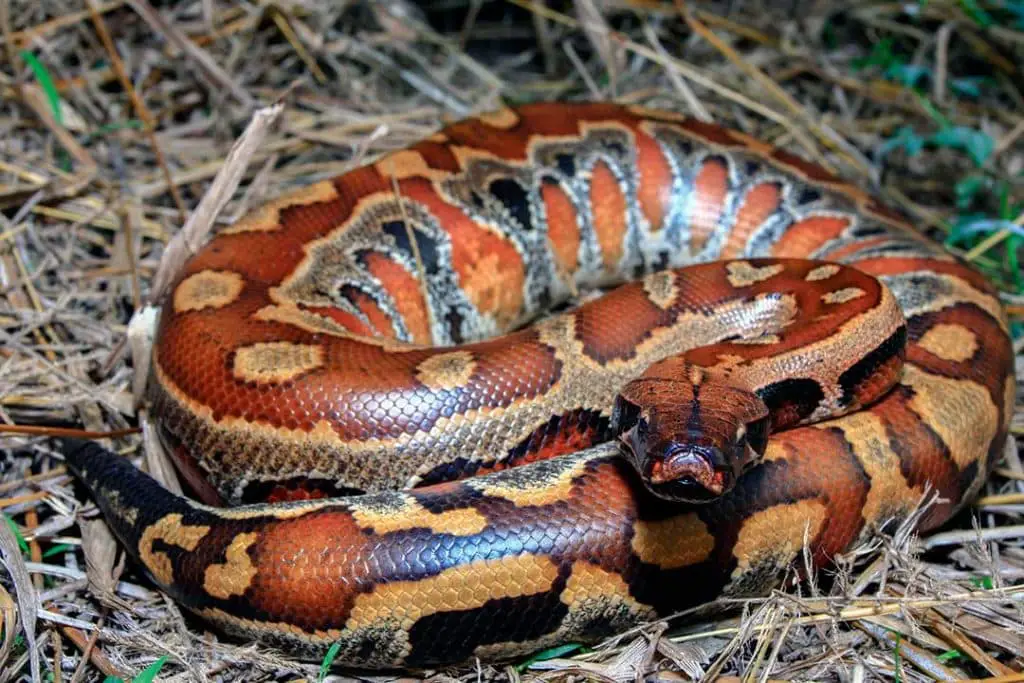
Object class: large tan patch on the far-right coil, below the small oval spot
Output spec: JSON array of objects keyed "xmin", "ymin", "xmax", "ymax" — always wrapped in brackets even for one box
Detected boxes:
[{"xmin": 901, "ymin": 364, "xmax": 999, "ymax": 469}]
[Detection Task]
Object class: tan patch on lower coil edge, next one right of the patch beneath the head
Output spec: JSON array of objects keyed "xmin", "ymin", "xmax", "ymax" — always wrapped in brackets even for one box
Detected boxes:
[{"xmin": 732, "ymin": 501, "xmax": 826, "ymax": 578}]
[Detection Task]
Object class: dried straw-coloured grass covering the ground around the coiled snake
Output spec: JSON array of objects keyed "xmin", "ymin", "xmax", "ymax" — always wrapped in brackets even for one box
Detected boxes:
[{"xmin": 0, "ymin": 0, "xmax": 1024, "ymax": 682}]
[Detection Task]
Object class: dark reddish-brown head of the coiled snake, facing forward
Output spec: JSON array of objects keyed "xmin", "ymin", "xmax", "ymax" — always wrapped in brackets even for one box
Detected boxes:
[{"xmin": 611, "ymin": 358, "xmax": 769, "ymax": 503}]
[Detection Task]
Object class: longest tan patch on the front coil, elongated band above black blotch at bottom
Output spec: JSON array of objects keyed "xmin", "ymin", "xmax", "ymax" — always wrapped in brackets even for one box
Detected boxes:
[{"xmin": 345, "ymin": 555, "xmax": 558, "ymax": 631}]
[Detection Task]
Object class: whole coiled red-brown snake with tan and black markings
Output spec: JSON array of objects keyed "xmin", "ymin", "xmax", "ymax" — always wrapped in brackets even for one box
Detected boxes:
[{"xmin": 68, "ymin": 103, "xmax": 1015, "ymax": 669}]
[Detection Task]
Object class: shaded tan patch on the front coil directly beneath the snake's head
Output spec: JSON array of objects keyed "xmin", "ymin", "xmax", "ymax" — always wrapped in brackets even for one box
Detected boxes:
[{"xmin": 633, "ymin": 512, "xmax": 715, "ymax": 569}]
